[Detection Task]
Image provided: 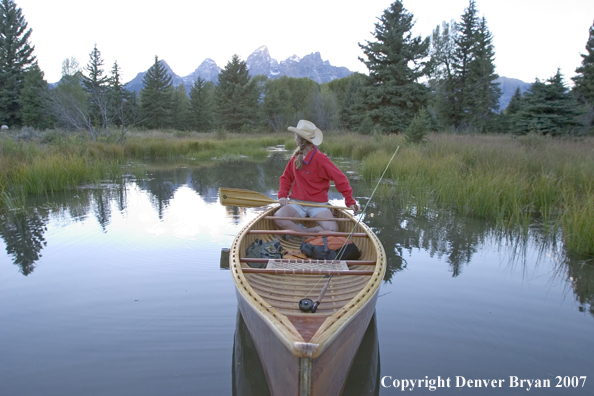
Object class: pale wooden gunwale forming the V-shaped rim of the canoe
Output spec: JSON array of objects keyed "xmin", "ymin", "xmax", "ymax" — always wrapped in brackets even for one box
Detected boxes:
[{"xmin": 229, "ymin": 206, "xmax": 386, "ymax": 358}]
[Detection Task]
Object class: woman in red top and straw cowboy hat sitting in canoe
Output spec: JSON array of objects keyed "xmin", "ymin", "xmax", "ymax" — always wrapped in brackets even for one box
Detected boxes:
[{"xmin": 275, "ymin": 120, "xmax": 359, "ymax": 232}]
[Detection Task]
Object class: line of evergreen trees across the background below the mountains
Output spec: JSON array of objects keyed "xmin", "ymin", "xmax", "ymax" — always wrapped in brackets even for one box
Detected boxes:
[{"xmin": 0, "ymin": 0, "xmax": 594, "ymax": 141}]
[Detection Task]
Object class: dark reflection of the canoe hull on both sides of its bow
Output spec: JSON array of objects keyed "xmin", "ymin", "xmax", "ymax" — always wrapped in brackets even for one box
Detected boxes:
[{"xmin": 232, "ymin": 311, "xmax": 380, "ymax": 396}]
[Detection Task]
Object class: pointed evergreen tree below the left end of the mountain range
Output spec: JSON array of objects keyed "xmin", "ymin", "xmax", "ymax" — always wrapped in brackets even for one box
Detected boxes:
[{"xmin": 140, "ymin": 56, "xmax": 173, "ymax": 129}]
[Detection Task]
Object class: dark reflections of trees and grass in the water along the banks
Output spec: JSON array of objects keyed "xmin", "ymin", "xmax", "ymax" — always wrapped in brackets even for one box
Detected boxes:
[{"xmin": 0, "ymin": 155, "xmax": 594, "ymax": 315}]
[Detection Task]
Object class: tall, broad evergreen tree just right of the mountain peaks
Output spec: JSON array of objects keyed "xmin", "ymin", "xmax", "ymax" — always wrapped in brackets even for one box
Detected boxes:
[{"xmin": 359, "ymin": 1, "xmax": 429, "ymax": 132}]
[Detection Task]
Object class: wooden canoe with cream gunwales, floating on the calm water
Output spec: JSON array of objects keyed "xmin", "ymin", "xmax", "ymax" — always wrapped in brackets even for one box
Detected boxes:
[{"xmin": 229, "ymin": 207, "xmax": 386, "ymax": 396}]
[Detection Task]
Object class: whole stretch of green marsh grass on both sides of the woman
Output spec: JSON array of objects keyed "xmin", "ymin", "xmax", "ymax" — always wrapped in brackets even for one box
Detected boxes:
[{"xmin": 0, "ymin": 131, "xmax": 594, "ymax": 254}]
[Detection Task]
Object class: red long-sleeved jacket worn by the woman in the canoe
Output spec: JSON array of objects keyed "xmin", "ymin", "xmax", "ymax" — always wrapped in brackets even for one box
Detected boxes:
[{"xmin": 278, "ymin": 146, "xmax": 356, "ymax": 206}]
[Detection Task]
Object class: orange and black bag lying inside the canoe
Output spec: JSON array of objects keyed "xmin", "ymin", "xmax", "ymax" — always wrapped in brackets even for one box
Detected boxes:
[{"xmin": 301, "ymin": 236, "xmax": 361, "ymax": 260}]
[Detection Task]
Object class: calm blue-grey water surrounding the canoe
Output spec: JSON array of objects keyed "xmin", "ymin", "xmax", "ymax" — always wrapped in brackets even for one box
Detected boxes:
[{"xmin": 0, "ymin": 158, "xmax": 594, "ymax": 396}]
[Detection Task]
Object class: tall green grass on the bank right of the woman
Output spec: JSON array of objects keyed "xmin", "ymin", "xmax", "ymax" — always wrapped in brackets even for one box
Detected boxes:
[{"xmin": 354, "ymin": 134, "xmax": 594, "ymax": 254}]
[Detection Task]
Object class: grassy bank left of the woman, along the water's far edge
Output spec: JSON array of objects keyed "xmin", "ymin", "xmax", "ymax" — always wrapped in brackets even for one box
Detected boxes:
[{"xmin": 0, "ymin": 130, "xmax": 292, "ymax": 207}]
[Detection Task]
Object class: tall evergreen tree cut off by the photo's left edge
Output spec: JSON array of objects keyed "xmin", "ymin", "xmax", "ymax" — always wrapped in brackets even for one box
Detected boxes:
[{"xmin": 0, "ymin": 0, "xmax": 35, "ymax": 125}]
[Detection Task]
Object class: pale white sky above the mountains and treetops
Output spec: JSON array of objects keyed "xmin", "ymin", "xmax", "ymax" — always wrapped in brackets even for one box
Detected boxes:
[{"xmin": 15, "ymin": 0, "xmax": 594, "ymax": 85}]
